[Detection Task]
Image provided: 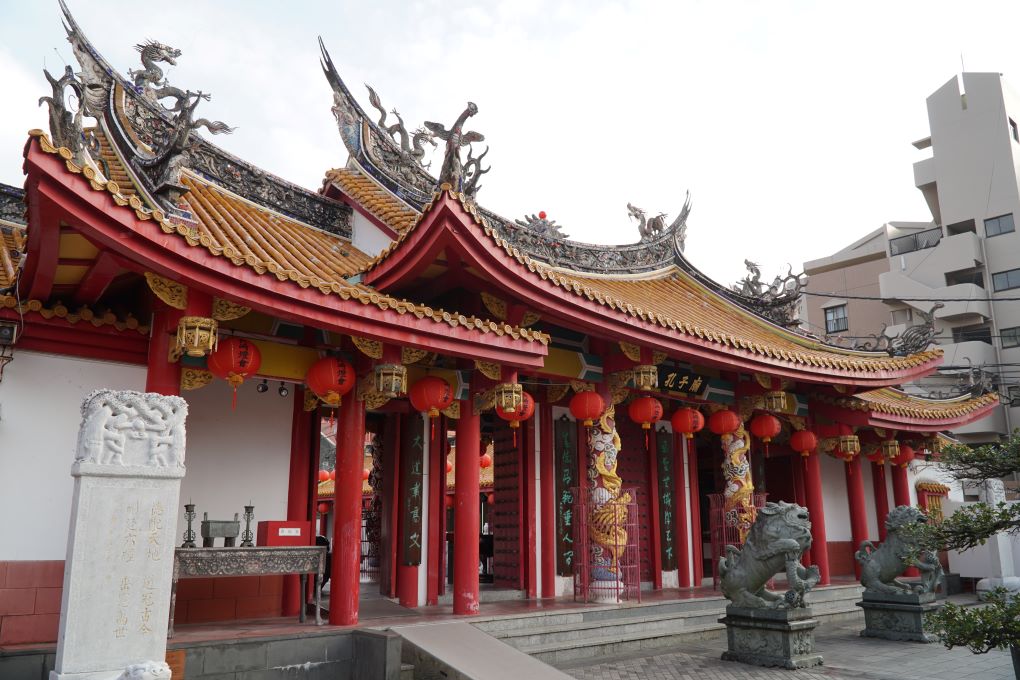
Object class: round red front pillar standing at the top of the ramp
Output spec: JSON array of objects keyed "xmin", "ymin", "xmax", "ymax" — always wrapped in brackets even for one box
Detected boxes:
[{"xmin": 453, "ymin": 399, "xmax": 481, "ymax": 615}]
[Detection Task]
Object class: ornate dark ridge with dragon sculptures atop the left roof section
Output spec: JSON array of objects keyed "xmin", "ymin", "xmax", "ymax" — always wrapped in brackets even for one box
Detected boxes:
[{"xmin": 57, "ymin": 0, "xmax": 352, "ymax": 239}]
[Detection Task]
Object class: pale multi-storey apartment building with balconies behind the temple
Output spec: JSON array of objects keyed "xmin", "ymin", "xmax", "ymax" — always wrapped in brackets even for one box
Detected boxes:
[{"xmin": 803, "ymin": 73, "xmax": 1020, "ymax": 442}]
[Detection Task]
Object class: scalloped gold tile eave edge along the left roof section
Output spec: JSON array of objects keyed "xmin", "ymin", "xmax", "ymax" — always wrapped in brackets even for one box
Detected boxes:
[{"xmin": 29, "ymin": 129, "xmax": 549, "ymax": 345}]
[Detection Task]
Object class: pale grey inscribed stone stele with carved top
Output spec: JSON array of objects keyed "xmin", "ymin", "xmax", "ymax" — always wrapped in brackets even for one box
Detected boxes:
[{"xmin": 50, "ymin": 389, "xmax": 188, "ymax": 680}]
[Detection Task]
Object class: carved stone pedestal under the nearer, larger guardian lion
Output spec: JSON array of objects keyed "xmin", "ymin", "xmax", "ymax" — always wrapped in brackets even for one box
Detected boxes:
[{"xmin": 719, "ymin": 605, "xmax": 822, "ymax": 670}]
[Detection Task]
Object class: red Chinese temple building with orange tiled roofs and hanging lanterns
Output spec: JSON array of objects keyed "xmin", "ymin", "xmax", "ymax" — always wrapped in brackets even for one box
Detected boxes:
[{"xmin": 0, "ymin": 1, "xmax": 998, "ymax": 645}]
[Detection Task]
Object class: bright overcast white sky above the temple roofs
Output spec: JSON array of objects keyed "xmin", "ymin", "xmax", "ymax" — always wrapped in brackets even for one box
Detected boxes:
[{"xmin": 0, "ymin": 0, "xmax": 1020, "ymax": 282}]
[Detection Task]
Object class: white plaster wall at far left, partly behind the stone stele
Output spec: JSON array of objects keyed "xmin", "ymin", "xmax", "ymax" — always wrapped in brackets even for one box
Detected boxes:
[{"xmin": 0, "ymin": 351, "xmax": 145, "ymax": 560}]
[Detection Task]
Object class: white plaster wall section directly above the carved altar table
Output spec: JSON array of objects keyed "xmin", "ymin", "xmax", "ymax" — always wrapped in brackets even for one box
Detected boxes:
[{"xmin": 177, "ymin": 380, "xmax": 294, "ymax": 542}]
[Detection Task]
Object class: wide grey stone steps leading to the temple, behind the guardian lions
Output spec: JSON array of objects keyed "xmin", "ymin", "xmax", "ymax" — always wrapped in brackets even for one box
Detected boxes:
[{"xmin": 474, "ymin": 585, "xmax": 861, "ymax": 665}]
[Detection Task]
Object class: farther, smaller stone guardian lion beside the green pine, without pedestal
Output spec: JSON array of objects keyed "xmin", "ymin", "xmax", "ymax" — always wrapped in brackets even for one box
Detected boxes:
[{"xmin": 855, "ymin": 506, "xmax": 942, "ymax": 594}]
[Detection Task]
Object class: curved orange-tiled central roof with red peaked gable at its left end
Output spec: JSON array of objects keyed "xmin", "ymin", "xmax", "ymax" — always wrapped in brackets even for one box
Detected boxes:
[{"xmin": 365, "ymin": 189, "xmax": 942, "ymax": 384}]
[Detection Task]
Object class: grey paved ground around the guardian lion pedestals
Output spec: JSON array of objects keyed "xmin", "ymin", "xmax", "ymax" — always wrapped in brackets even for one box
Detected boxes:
[{"xmin": 562, "ymin": 623, "xmax": 1014, "ymax": 680}]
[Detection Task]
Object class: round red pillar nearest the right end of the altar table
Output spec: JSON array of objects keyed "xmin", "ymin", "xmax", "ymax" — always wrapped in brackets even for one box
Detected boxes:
[{"xmin": 329, "ymin": 395, "xmax": 365, "ymax": 626}]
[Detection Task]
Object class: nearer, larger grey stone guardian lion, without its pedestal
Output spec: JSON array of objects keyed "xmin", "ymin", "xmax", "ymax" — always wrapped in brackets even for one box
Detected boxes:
[{"xmin": 719, "ymin": 501, "xmax": 818, "ymax": 609}]
